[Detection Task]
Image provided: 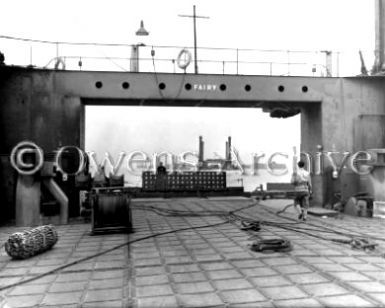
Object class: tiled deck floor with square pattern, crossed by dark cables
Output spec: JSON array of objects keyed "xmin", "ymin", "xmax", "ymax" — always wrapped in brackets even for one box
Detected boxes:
[{"xmin": 0, "ymin": 198, "xmax": 385, "ymax": 307}]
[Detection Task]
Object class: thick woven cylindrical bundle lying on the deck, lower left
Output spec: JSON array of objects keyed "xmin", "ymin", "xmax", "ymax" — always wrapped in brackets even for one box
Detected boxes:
[{"xmin": 4, "ymin": 225, "xmax": 58, "ymax": 259}]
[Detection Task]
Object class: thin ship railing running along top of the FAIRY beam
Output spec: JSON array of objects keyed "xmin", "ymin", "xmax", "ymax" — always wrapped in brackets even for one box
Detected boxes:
[{"xmin": 0, "ymin": 35, "xmax": 374, "ymax": 77}]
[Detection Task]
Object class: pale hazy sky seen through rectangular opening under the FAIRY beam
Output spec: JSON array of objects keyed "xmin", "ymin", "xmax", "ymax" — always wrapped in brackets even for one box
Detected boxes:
[{"xmin": 84, "ymin": 105, "xmax": 301, "ymax": 191}]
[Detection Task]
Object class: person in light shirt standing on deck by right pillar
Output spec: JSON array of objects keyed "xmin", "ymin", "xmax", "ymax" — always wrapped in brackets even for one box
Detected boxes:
[{"xmin": 291, "ymin": 160, "xmax": 312, "ymax": 220}]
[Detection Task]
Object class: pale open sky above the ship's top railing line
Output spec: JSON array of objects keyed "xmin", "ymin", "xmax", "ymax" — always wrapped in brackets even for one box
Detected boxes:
[{"xmin": 0, "ymin": 0, "xmax": 374, "ymax": 72}]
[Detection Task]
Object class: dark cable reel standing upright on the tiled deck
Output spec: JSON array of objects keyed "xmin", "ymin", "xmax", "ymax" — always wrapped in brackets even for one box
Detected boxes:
[{"xmin": 91, "ymin": 190, "xmax": 132, "ymax": 233}]
